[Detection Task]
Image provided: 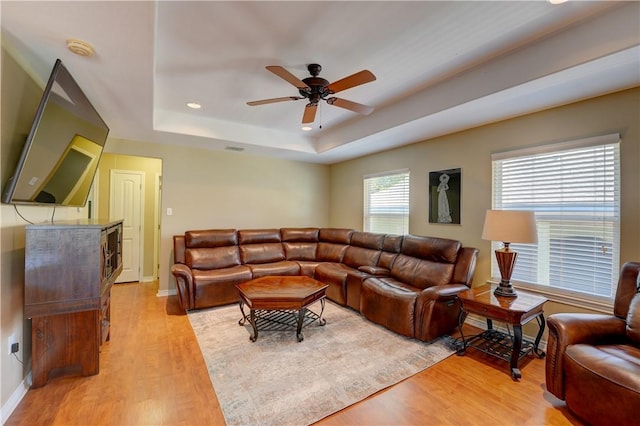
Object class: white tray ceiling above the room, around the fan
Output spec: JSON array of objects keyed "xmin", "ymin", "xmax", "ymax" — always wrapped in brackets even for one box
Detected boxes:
[{"xmin": 0, "ymin": 1, "xmax": 640, "ymax": 163}]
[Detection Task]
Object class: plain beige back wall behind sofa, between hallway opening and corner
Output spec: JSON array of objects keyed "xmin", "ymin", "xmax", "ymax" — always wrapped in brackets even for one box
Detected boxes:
[{"xmin": 106, "ymin": 139, "xmax": 329, "ymax": 293}]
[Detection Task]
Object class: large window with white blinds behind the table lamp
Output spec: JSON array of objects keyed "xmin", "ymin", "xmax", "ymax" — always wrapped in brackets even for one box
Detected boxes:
[{"xmin": 492, "ymin": 134, "xmax": 620, "ymax": 300}]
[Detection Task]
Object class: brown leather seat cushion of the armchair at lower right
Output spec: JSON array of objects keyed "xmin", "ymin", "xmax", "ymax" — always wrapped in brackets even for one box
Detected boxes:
[{"xmin": 564, "ymin": 344, "xmax": 640, "ymax": 425}]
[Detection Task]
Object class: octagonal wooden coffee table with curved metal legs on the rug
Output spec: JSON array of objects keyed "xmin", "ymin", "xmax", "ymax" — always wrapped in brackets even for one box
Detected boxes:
[{"xmin": 236, "ymin": 276, "xmax": 329, "ymax": 342}]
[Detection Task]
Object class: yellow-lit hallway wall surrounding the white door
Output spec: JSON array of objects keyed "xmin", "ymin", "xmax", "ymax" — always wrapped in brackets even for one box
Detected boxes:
[{"xmin": 94, "ymin": 153, "xmax": 162, "ymax": 281}]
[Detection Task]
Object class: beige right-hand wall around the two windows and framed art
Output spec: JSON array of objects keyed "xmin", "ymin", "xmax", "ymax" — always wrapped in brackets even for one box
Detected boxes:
[{"xmin": 329, "ymin": 88, "xmax": 640, "ymax": 326}]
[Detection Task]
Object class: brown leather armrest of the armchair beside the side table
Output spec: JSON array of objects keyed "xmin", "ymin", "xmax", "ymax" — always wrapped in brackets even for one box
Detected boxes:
[{"xmin": 545, "ymin": 313, "xmax": 626, "ymax": 400}]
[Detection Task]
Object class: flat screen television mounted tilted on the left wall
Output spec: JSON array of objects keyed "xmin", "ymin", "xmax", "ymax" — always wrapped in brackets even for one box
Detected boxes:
[{"xmin": 2, "ymin": 59, "xmax": 109, "ymax": 207}]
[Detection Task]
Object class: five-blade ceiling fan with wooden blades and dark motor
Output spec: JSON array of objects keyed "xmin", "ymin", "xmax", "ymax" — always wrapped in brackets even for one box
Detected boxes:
[{"xmin": 247, "ymin": 64, "xmax": 376, "ymax": 124}]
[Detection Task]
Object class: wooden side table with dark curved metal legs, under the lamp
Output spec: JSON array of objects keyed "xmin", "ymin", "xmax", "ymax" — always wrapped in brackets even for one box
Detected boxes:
[{"xmin": 458, "ymin": 284, "xmax": 547, "ymax": 380}]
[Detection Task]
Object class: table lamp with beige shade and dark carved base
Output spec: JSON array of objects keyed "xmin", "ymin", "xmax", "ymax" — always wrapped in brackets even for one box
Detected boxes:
[{"xmin": 482, "ymin": 210, "xmax": 538, "ymax": 297}]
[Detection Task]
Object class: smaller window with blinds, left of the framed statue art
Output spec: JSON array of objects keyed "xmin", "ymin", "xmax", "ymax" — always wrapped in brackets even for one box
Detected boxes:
[{"xmin": 364, "ymin": 170, "xmax": 409, "ymax": 234}]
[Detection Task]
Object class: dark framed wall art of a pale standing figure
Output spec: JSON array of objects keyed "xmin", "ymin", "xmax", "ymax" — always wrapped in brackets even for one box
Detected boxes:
[{"xmin": 429, "ymin": 169, "xmax": 462, "ymax": 225}]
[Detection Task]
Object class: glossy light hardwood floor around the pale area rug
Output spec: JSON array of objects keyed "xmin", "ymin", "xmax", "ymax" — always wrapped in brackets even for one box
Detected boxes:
[{"xmin": 5, "ymin": 283, "xmax": 581, "ymax": 425}]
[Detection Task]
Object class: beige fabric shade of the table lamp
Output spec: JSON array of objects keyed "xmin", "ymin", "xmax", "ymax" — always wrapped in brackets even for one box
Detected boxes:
[{"xmin": 482, "ymin": 210, "xmax": 538, "ymax": 243}]
